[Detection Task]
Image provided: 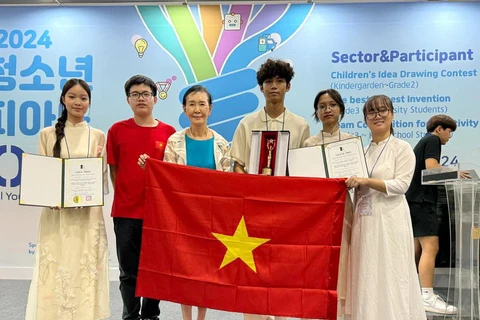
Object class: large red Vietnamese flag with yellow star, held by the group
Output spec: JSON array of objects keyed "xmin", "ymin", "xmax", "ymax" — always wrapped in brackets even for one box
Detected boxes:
[{"xmin": 137, "ymin": 159, "xmax": 347, "ymax": 320}]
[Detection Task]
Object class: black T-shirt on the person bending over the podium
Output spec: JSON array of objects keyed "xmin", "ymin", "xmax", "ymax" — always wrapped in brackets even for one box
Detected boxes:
[{"xmin": 405, "ymin": 134, "xmax": 442, "ymax": 203}]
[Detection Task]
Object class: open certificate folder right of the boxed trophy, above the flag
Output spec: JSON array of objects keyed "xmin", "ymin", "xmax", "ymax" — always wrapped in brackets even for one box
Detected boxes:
[{"xmin": 288, "ymin": 137, "xmax": 368, "ymax": 178}]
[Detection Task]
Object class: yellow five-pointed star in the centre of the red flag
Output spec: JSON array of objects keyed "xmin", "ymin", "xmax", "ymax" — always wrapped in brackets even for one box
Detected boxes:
[{"xmin": 212, "ymin": 216, "xmax": 270, "ymax": 272}]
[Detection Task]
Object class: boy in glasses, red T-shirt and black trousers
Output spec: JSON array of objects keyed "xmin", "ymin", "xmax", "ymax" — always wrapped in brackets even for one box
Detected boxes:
[{"xmin": 107, "ymin": 75, "xmax": 175, "ymax": 320}]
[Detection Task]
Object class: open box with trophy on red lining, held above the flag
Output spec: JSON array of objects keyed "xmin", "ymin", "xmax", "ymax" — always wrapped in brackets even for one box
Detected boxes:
[{"xmin": 248, "ymin": 131, "xmax": 290, "ymax": 176}]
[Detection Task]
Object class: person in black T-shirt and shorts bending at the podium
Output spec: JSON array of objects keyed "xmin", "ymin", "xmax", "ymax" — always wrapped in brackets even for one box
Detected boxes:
[{"xmin": 406, "ymin": 115, "xmax": 457, "ymax": 314}]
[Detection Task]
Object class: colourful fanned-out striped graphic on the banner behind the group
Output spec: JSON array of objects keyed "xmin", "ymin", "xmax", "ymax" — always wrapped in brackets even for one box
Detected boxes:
[{"xmin": 137, "ymin": 4, "xmax": 314, "ymax": 141}]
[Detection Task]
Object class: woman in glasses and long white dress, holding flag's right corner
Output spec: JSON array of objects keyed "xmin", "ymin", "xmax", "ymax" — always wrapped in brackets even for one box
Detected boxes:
[{"xmin": 345, "ymin": 95, "xmax": 426, "ymax": 320}]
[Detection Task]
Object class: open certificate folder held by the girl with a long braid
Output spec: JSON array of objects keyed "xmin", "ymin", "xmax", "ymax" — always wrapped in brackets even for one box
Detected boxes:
[{"xmin": 19, "ymin": 153, "xmax": 104, "ymax": 208}]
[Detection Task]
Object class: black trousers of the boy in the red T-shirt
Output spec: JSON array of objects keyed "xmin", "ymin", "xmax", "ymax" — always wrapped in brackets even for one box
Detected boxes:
[{"xmin": 113, "ymin": 218, "xmax": 160, "ymax": 320}]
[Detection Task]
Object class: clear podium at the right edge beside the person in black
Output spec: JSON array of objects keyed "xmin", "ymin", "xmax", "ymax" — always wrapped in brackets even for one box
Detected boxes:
[{"xmin": 422, "ymin": 164, "xmax": 480, "ymax": 320}]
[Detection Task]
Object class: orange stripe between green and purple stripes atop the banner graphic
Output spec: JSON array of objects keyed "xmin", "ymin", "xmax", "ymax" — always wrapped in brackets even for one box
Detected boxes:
[{"xmin": 199, "ymin": 5, "xmax": 223, "ymax": 56}]
